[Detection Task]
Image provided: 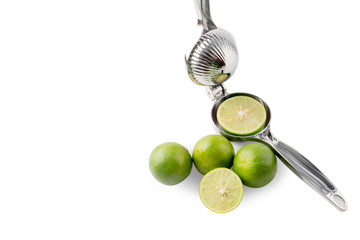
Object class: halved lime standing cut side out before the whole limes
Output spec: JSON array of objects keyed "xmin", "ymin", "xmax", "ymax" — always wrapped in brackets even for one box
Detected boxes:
[{"xmin": 199, "ymin": 168, "xmax": 244, "ymax": 213}]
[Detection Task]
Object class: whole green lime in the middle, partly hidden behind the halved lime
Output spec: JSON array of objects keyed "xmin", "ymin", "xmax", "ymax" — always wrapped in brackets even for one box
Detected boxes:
[{"xmin": 193, "ymin": 135, "xmax": 235, "ymax": 174}]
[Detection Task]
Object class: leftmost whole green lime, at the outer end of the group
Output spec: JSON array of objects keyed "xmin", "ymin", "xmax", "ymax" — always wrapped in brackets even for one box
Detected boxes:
[{"xmin": 149, "ymin": 142, "xmax": 192, "ymax": 185}]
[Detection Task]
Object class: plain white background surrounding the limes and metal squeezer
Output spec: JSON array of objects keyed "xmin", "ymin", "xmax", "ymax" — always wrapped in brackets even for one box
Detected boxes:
[{"xmin": 0, "ymin": 0, "xmax": 360, "ymax": 240}]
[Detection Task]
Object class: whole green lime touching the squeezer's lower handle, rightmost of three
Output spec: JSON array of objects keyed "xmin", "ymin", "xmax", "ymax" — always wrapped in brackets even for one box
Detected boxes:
[{"xmin": 234, "ymin": 143, "xmax": 277, "ymax": 188}]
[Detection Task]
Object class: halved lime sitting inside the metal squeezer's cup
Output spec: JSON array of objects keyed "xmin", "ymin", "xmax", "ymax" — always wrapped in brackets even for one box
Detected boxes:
[{"xmin": 216, "ymin": 96, "xmax": 266, "ymax": 135}]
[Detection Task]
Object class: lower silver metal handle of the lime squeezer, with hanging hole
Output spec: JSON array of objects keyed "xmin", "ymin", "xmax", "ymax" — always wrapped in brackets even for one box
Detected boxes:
[{"xmin": 261, "ymin": 132, "xmax": 348, "ymax": 211}]
